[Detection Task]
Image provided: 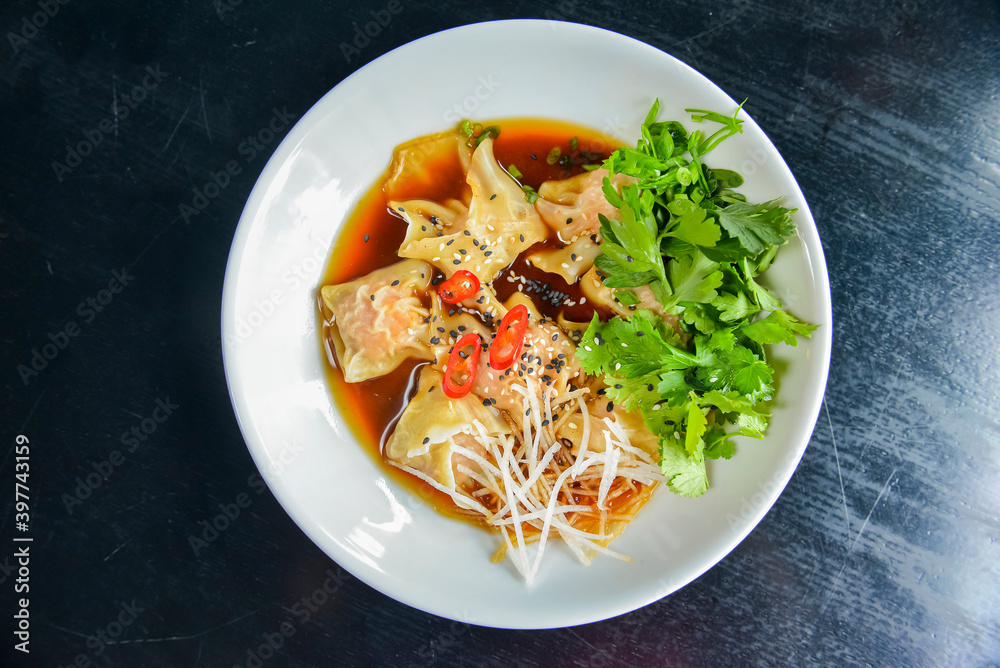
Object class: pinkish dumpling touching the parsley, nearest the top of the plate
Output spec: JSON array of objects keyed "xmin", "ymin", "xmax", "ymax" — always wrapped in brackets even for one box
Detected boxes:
[{"xmin": 535, "ymin": 168, "xmax": 635, "ymax": 243}]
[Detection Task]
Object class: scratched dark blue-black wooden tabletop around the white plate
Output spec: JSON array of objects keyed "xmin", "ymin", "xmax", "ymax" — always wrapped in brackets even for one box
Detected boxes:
[{"xmin": 0, "ymin": 0, "xmax": 1000, "ymax": 666}]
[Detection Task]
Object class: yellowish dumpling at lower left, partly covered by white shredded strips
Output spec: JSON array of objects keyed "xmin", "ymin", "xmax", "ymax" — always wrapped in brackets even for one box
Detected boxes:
[{"xmin": 385, "ymin": 366, "xmax": 511, "ymax": 490}]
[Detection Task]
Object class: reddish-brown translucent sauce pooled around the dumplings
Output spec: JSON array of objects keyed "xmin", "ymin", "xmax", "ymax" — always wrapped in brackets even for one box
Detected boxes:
[{"xmin": 316, "ymin": 119, "xmax": 618, "ymax": 524}]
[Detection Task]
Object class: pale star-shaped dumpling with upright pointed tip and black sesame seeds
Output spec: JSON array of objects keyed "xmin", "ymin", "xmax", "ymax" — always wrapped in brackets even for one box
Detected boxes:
[{"xmin": 389, "ymin": 138, "xmax": 547, "ymax": 283}]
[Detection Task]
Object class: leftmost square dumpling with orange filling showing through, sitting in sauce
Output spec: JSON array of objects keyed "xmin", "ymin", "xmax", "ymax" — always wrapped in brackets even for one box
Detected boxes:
[{"xmin": 320, "ymin": 260, "xmax": 434, "ymax": 383}]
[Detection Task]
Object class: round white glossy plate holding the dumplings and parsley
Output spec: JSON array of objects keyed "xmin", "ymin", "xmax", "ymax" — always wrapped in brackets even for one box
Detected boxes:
[{"xmin": 222, "ymin": 21, "xmax": 832, "ymax": 629}]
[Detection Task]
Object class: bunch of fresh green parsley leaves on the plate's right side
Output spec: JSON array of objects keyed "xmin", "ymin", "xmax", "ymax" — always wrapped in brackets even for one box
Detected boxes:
[{"xmin": 577, "ymin": 100, "xmax": 816, "ymax": 496}]
